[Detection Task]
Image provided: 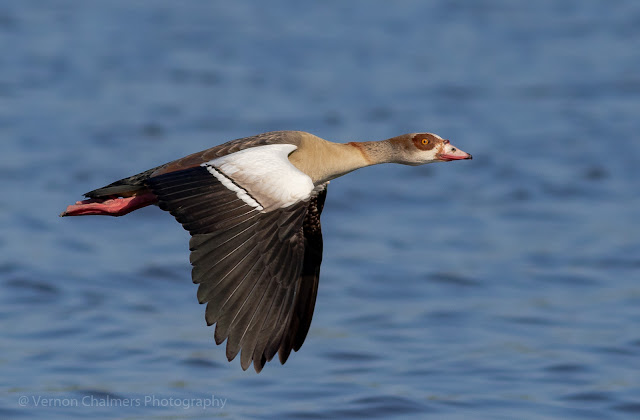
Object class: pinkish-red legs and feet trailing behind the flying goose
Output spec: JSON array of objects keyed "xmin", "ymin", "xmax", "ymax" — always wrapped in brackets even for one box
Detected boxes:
[{"xmin": 60, "ymin": 193, "xmax": 158, "ymax": 217}]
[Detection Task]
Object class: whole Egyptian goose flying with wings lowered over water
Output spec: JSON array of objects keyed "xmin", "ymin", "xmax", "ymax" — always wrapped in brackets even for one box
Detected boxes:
[{"xmin": 61, "ymin": 131, "xmax": 471, "ymax": 372}]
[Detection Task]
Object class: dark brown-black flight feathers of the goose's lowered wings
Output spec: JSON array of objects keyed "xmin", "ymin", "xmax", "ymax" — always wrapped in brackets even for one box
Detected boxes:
[{"xmin": 147, "ymin": 167, "xmax": 326, "ymax": 372}]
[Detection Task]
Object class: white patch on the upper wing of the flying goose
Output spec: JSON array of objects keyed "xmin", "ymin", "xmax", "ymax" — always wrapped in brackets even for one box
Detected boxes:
[{"xmin": 202, "ymin": 144, "xmax": 314, "ymax": 212}]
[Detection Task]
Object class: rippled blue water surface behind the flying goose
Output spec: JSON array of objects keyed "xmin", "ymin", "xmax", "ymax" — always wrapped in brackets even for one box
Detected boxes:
[{"xmin": 0, "ymin": 0, "xmax": 640, "ymax": 419}]
